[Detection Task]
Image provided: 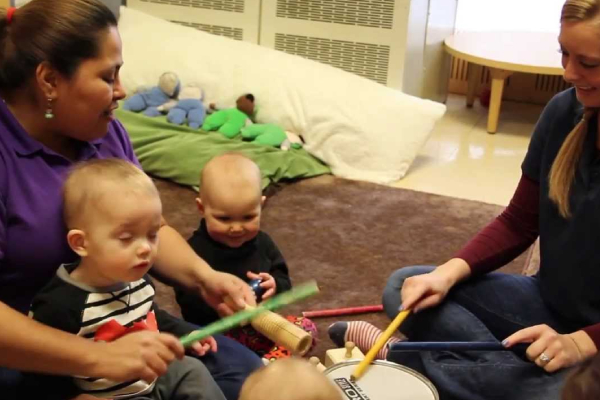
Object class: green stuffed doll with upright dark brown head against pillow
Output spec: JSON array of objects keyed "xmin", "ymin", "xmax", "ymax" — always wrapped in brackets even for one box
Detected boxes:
[{"xmin": 202, "ymin": 94, "xmax": 254, "ymax": 139}]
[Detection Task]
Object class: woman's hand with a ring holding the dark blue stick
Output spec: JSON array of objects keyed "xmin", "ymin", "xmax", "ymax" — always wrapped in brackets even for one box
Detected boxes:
[{"xmin": 503, "ymin": 325, "xmax": 597, "ymax": 372}]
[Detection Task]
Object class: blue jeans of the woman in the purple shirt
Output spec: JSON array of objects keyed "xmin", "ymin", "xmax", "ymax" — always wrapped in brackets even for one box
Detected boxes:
[{"xmin": 0, "ymin": 335, "xmax": 263, "ymax": 400}]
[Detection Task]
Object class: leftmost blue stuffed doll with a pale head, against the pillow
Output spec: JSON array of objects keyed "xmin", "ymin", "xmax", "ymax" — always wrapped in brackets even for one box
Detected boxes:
[{"xmin": 123, "ymin": 72, "xmax": 180, "ymax": 117}]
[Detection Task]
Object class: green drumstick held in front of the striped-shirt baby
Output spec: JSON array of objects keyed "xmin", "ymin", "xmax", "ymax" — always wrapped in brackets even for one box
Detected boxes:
[{"xmin": 179, "ymin": 281, "xmax": 319, "ymax": 347}]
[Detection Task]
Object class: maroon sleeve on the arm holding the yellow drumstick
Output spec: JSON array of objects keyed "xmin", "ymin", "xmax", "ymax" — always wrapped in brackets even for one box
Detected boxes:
[{"xmin": 455, "ymin": 175, "xmax": 540, "ymax": 276}]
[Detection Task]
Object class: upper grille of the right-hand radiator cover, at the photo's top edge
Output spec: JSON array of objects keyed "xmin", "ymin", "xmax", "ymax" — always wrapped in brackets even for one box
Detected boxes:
[{"xmin": 277, "ymin": 0, "xmax": 395, "ymax": 29}]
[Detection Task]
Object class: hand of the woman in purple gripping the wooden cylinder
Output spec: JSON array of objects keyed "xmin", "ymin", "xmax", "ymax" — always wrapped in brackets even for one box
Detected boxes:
[{"xmin": 200, "ymin": 270, "xmax": 256, "ymax": 316}]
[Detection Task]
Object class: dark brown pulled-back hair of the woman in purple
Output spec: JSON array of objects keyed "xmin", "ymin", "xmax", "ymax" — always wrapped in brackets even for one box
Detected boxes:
[{"xmin": 0, "ymin": 0, "xmax": 117, "ymax": 91}]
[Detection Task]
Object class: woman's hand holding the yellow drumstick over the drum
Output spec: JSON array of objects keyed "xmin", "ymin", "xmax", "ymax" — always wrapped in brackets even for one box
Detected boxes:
[{"xmin": 401, "ymin": 258, "xmax": 471, "ymax": 313}]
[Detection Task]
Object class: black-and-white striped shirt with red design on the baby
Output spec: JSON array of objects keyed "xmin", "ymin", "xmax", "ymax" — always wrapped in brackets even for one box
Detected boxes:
[{"xmin": 30, "ymin": 264, "xmax": 196, "ymax": 399}]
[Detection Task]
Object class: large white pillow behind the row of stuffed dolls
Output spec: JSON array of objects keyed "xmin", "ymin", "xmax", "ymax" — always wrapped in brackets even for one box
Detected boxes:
[{"xmin": 119, "ymin": 7, "xmax": 446, "ymax": 183}]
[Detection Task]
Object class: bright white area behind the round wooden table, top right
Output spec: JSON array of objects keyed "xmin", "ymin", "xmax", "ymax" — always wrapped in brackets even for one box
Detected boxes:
[{"xmin": 456, "ymin": 0, "xmax": 565, "ymax": 32}]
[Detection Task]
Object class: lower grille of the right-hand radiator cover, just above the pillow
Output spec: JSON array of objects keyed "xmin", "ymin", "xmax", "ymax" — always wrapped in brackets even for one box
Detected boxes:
[{"xmin": 275, "ymin": 33, "xmax": 390, "ymax": 85}]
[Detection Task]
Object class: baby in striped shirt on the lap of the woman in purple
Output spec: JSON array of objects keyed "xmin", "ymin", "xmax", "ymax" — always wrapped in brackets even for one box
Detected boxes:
[{"xmin": 23, "ymin": 159, "xmax": 225, "ymax": 400}]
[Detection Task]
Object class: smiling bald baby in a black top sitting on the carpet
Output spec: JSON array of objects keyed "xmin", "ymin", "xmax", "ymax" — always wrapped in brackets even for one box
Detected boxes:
[{"xmin": 177, "ymin": 153, "xmax": 291, "ymax": 325}]
